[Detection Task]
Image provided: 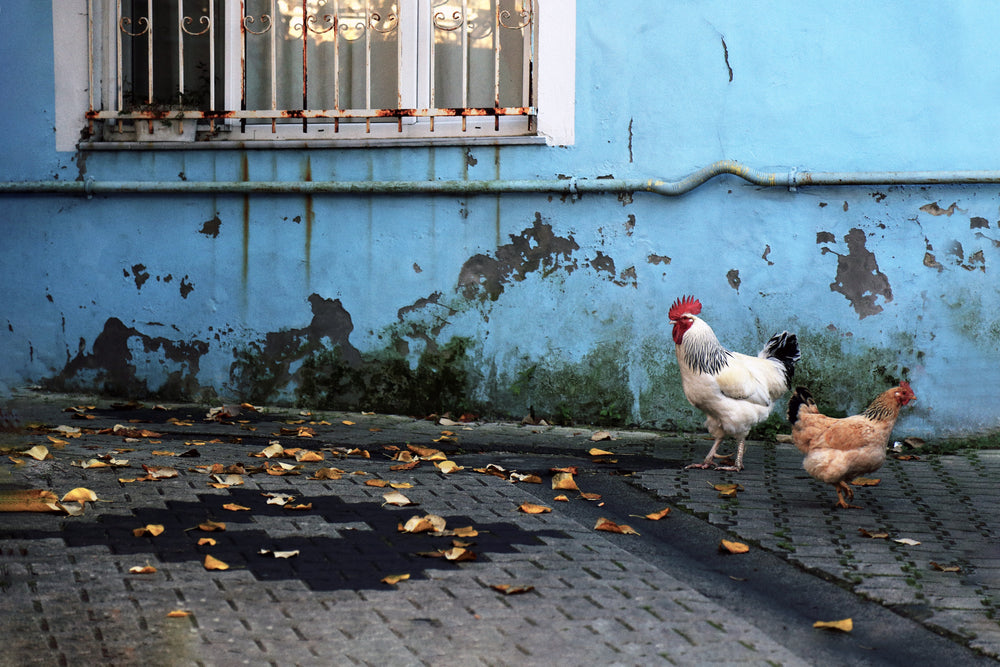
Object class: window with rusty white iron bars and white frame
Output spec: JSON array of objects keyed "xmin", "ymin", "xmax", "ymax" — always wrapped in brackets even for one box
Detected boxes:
[{"xmin": 62, "ymin": 0, "xmax": 575, "ymax": 148}]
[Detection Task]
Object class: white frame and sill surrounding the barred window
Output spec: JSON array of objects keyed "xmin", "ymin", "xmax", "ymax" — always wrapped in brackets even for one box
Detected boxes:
[{"xmin": 52, "ymin": 0, "xmax": 576, "ymax": 151}]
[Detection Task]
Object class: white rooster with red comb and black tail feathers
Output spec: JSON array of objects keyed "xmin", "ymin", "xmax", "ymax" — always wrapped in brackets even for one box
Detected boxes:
[{"xmin": 669, "ymin": 296, "xmax": 799, "ymax": 471}]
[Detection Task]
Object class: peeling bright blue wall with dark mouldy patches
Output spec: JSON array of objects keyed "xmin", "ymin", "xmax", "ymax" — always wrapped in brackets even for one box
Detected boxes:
[{"xmin": 0, "ymin": 0, "xmax": 1000, "ymax": 436}]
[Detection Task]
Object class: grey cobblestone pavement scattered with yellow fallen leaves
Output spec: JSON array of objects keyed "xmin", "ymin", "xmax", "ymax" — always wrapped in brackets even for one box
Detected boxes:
[{"xmin": 0, "ymin": 395, "xmax": 1000, "ymax": 665}]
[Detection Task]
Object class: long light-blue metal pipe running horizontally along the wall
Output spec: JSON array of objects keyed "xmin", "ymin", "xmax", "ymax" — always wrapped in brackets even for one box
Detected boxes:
[{"xmin": 0, "ymin": 160, "xmax": 1000, "ymax": 197}]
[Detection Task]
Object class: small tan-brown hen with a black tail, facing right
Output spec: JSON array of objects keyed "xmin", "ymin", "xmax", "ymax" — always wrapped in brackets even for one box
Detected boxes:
[{"xmin": 788, "ymin": 381, "xmax": 917, "ymax": 509}]
